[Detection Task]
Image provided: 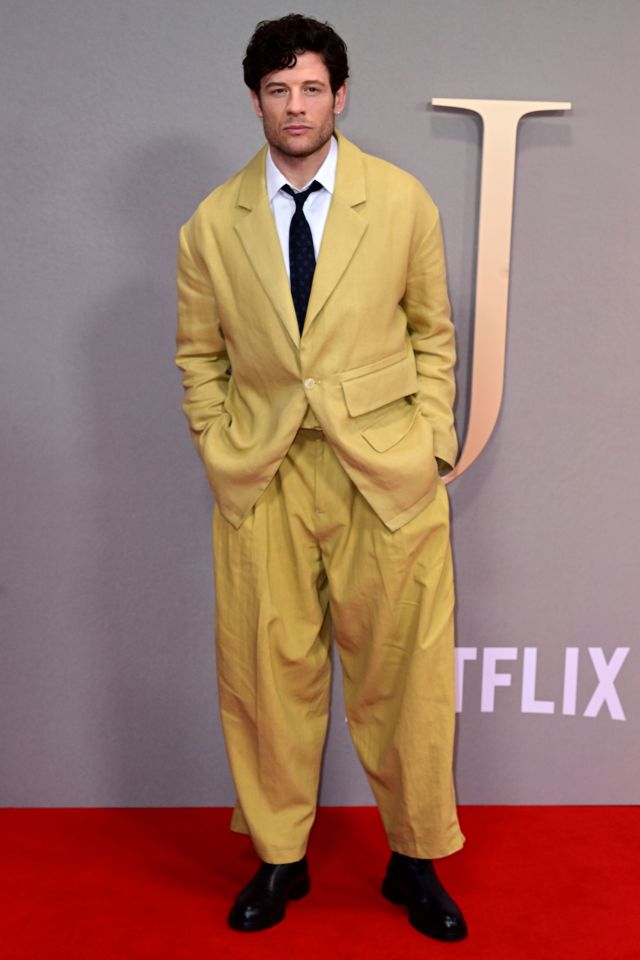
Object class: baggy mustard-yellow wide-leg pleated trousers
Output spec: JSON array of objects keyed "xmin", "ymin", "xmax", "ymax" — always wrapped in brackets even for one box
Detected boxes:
[{"xmin": 213, "ymin": 429, "xmax": 464, "ymax": 863}]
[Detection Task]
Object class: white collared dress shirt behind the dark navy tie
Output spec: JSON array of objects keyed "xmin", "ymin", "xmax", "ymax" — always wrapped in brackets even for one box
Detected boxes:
[{"xmin": 266, "ymin": 137, "xmax": 338, "ymax": 276}]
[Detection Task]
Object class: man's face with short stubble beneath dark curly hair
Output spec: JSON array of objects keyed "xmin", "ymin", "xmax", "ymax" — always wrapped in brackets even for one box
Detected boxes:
[{"xmin": 251, "ymin": 52, "xmax": 347, "ymax": 159}]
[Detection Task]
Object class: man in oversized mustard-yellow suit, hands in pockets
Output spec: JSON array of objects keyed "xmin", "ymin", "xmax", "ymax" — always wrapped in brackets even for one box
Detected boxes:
[{"xmin": 176, "ymin": 14, "xmax": 466, "ymax": 940}]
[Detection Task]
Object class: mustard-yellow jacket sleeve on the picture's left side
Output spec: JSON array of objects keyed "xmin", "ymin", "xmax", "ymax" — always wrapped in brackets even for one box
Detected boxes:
[{"xmin": 175, "ymin": 218, "xmax": 230, "ymax": 456}]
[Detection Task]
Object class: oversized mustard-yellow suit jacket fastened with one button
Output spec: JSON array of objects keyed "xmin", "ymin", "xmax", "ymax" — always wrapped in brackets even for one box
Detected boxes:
[{"xmin": 176, "ymin": 134, "xmax": 457, "ymax": 530}]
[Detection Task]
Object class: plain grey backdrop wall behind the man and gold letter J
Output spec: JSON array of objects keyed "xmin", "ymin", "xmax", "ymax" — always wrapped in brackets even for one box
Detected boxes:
[{"xmin": 0, "ymin": 0, "xmax": 640, "ymax": 806}]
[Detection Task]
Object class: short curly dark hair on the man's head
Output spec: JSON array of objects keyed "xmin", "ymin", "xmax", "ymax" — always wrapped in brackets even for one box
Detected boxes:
[{"xmin": 242, "ymin": 13, "xmax": 349, "ymax": 94}]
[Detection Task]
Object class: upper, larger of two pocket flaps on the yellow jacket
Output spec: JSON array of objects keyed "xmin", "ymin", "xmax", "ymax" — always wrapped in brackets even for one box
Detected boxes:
[{"xmin": 341, "ymin": 351, "xmax": 418, "ymax": 417}]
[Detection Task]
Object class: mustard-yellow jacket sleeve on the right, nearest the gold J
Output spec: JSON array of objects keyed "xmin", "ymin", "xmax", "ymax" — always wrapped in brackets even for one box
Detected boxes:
[{"xmin": 402, "ymin": 188, "xmax": 458, "ymax": 472}]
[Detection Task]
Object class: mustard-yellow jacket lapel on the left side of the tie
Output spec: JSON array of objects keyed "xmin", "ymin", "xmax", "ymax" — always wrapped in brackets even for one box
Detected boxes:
[{"xmin": 235, "ymin": 147, "xmax": 300, "ymax": 346}]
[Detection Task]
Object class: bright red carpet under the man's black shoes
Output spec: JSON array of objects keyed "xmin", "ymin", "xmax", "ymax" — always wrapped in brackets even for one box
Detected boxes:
[{"xmin": 0, "ymin": 807, "xmax": 640, "ymax": 960}]
